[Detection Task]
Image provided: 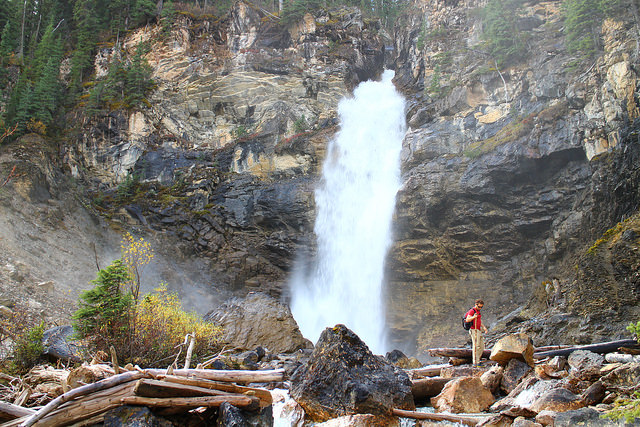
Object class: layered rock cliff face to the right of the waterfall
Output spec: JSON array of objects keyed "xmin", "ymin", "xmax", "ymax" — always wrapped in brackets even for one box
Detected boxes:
[{"xmin": 388, "ymin": 0, "xmax": 638, "ymax": 354}]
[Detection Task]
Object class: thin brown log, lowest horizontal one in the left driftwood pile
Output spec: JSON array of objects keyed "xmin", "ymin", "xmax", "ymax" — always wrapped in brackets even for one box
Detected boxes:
[{"xmin": 121, "ymin": 394, "xmax": 260, "ymax": 411}]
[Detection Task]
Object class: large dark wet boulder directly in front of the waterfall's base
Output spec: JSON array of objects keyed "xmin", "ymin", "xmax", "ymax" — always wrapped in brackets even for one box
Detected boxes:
[{"xmin": 291, "ymin": 325, "xmax": 415, "ymax": 422}]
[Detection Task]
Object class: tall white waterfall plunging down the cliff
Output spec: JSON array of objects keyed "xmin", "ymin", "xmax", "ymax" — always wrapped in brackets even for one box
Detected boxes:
[{"xmin": 291, "ymin": 71, "xmax": 405, "ymax": 354}]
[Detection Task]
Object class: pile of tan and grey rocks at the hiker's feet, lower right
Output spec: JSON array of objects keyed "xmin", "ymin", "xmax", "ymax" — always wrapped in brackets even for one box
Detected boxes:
[{"xmin": 410, "ymin": 334, "xmax": 640, "ymax": 426}]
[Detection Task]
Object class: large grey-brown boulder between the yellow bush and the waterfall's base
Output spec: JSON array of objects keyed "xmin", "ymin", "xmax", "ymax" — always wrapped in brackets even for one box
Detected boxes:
[{"xmin": 205, "ymin": 293, "xmax": 313, "ymax": 353}]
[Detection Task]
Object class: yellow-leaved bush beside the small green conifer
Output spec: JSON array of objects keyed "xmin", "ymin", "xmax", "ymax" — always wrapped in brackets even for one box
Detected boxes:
[{"xmin": 132, "ymin": 286, "xmax": 222, "ymax": 366}]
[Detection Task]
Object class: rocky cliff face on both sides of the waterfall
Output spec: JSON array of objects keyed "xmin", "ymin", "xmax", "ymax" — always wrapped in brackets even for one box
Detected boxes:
[{"xmin": 0, "ymin": 0, "xmax": 640, "ymax": 362}]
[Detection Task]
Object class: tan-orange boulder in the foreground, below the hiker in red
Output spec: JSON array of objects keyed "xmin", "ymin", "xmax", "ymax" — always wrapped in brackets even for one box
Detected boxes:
[{"xmin": 431, "ymin": 377, "xmax": 495, "ymax": 414}]
